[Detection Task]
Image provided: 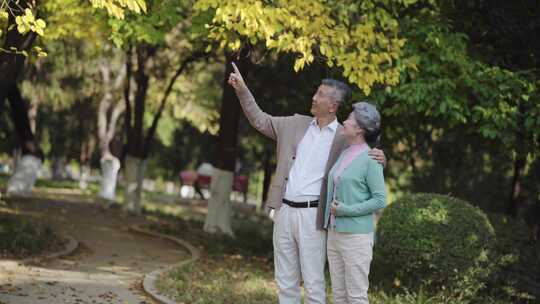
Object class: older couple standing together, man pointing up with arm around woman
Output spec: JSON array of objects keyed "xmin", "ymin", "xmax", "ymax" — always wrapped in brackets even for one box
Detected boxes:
[{"xmin": 229, "ymin": 63, "xmax": 386, "ymax": 304}]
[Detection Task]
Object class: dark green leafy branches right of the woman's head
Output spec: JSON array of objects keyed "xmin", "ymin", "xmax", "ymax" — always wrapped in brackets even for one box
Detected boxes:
[{"xmin": 375, "ymin": 17, "xmax": 540, "ymax": 144}]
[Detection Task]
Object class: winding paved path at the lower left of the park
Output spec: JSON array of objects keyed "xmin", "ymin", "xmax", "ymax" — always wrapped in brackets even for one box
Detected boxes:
[{"xmin": 0, "ymin": 195, "xmax": 188, "ymax": 304}]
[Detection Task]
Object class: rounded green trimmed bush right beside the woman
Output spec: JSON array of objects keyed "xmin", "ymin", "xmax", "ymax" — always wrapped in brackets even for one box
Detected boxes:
[{"xmin": 372, "ymin": 193, "xmax": 495, "ymax": 298}]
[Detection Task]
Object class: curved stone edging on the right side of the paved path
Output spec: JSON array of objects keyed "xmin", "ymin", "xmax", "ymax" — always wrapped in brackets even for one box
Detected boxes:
[{"xmin": 129, "ymin": 225, "xmax": 200, "ymax": 304}]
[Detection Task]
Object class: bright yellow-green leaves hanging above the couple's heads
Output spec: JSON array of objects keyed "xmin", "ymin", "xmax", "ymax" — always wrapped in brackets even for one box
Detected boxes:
[{"xmin": 195, "ymin": 0, "xmax": 424, "ymax": 95}]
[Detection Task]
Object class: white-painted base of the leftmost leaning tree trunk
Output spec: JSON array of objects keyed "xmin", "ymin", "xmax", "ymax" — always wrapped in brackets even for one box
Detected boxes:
[{"xmin": 7, "ymin": 155, "xmax": 42, "ymax": 195}]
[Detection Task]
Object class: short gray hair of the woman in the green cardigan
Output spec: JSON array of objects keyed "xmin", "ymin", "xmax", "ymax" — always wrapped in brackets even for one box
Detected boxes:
[{"xmin": 353, "ymin": 102, "xmax": 381, "ymax": 144}]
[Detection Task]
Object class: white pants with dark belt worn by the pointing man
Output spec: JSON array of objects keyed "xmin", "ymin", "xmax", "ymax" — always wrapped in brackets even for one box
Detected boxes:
[{"xmin": 273, "ymin": 205, "xmax": 326, "ymax": 304}]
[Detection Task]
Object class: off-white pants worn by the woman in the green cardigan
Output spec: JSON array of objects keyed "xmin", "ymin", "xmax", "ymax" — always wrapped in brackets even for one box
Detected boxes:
[{"xmin": 327, "ymin": 230, "xmax": 373, "ymax": 304}]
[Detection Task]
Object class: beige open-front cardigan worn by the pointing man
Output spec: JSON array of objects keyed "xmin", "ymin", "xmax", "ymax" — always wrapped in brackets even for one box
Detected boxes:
[{"xmin": 236, "ymin": 88, "xmax": 346, "ymax": 229}]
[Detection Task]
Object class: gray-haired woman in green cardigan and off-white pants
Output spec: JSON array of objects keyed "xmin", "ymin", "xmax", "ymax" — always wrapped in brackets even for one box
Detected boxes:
[{"xmin": 325, "ymin": 102, "xmax": 386, "ymax": 304}]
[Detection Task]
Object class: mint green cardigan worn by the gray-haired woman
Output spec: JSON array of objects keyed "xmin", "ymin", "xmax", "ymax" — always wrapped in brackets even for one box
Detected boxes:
[{"xmin": 324, "ymin": 150, "xmax": 386, "ymax": 234}]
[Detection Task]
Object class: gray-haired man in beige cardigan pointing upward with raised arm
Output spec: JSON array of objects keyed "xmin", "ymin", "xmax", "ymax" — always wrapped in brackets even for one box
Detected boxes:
[{"xmin": 229, "ymin": 63, "xmax": 385, "ymax": 304}]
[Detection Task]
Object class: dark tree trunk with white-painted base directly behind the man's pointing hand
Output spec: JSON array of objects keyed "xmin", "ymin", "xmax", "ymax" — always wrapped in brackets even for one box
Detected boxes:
[{"xmin": 204, "ymin": 50, "xmax": 249, "ymax": 236}]
